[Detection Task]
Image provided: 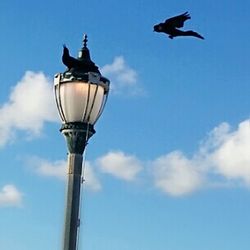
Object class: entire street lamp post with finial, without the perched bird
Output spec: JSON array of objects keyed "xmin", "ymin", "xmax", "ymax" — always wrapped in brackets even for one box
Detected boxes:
[{"xmin": 54, "ymin": 35, "xmax": 110, "ymax": 250}]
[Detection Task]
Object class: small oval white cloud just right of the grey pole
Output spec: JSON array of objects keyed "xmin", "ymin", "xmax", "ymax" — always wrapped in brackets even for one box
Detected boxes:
[{"xmin": 97, "ymin": 151, "xmax": 142, "ymax": 181}]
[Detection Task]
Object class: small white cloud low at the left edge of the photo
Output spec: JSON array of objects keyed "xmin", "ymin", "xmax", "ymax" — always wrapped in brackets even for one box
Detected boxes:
[{"xmin": 0, "ymin": 184, "xmax": 23, "ymax": 207}]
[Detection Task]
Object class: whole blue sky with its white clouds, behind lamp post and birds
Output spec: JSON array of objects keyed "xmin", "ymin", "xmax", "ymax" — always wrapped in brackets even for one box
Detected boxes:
[{"xmin": 0, "ymin": 0, "xmax": 250, "ymax": 250}]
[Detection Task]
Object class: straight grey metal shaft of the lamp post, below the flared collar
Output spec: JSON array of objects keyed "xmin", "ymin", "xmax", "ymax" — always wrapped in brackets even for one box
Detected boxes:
[{"xmin": 63, "ymin": 153, "xmax": 83, "ymax": 250}]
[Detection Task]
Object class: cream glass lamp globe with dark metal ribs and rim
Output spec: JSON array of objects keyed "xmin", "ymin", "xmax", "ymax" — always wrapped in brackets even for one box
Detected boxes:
[{"xmin": 54, "ymin": 72, "xmax": 109, "ymax": 125}]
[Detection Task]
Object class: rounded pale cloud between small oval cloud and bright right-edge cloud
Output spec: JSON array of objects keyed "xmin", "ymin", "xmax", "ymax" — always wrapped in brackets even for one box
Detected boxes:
[{"xmin": 152, "ymin": 151, "xmax": 203, "ymax": 196}]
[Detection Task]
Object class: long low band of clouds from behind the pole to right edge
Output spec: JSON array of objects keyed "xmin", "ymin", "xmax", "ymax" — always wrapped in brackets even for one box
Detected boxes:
[{"xmin": 23, "ymin": 120, "xmax": 250, "ymax": 196}]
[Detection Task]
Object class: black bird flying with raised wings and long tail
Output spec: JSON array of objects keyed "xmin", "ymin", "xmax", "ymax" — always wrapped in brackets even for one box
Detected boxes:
[{"xmin": 154, "ymin": 12, "xmax": 204, "ymax": 39}]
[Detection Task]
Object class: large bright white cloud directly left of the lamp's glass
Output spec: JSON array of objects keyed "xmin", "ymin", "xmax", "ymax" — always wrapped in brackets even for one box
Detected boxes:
[{"xmin": 0, "ymin": 71, "xmax": 58, "ymax": 146}]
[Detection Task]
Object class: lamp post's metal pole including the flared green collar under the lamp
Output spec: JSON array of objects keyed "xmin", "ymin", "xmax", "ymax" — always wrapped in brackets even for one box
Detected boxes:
[{"xmin": 61, "ymin": 122, "xmax": 95, "ymax": 250}]
